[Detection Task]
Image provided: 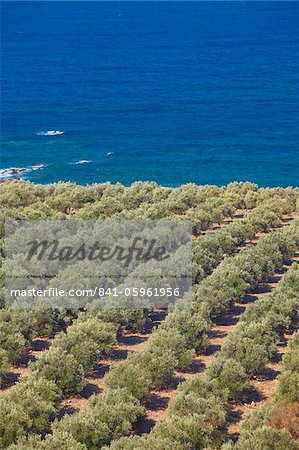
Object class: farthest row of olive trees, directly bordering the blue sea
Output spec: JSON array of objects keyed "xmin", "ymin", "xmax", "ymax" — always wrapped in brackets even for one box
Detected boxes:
[{"xmin": 0, "ymin": 180, "xmax": 298, "ymax": 218}]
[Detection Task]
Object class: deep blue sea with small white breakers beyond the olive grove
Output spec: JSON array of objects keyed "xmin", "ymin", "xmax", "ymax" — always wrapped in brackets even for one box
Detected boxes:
[{"xmin": 1, "ymin": 1, "xmax": 299, "ymax": 186}]
